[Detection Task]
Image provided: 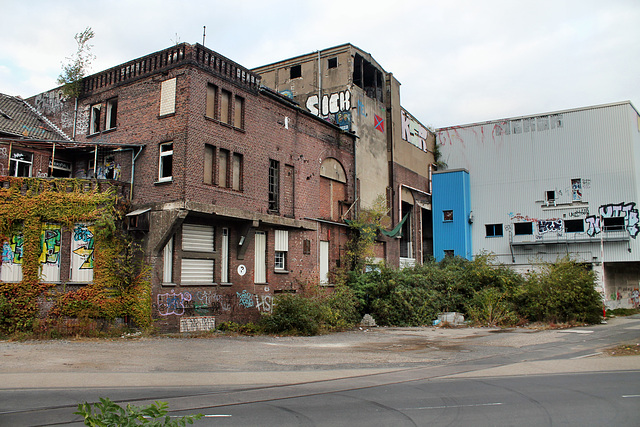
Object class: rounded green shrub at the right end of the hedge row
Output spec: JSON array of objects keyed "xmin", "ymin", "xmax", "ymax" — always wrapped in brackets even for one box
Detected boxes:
[{"xmin": 519, "ymin": 258, "xmax": 602, "ymax": 323}]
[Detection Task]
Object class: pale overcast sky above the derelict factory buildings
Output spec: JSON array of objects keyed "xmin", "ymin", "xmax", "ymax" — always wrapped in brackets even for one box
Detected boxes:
[{"xmin": 0, "ymin": 0, "xmax": 640, "ymax": 127}]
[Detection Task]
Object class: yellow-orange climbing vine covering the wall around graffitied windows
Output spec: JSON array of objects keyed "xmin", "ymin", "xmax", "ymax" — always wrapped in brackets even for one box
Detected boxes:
[{"xmin": 0, "ymin": 177, "xmax": 151, "ymax": 333}]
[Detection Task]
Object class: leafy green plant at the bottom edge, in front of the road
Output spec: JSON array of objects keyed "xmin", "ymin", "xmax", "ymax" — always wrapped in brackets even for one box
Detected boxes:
[{"xmin": 74, "ymin": 397, "xmax": 203, "ymax": 427}]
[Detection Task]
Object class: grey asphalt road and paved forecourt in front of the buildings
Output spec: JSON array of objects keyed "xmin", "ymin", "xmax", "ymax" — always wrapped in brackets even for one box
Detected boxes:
[{"xmin": 0, "ymin": 318, "xmax": 640, "ymax": 426}]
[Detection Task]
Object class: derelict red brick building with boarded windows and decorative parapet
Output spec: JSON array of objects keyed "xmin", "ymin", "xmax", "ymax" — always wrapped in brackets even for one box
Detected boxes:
[{"xmin": 23, "ymin": 43, "xmax": 355, "ymax": 329}]
